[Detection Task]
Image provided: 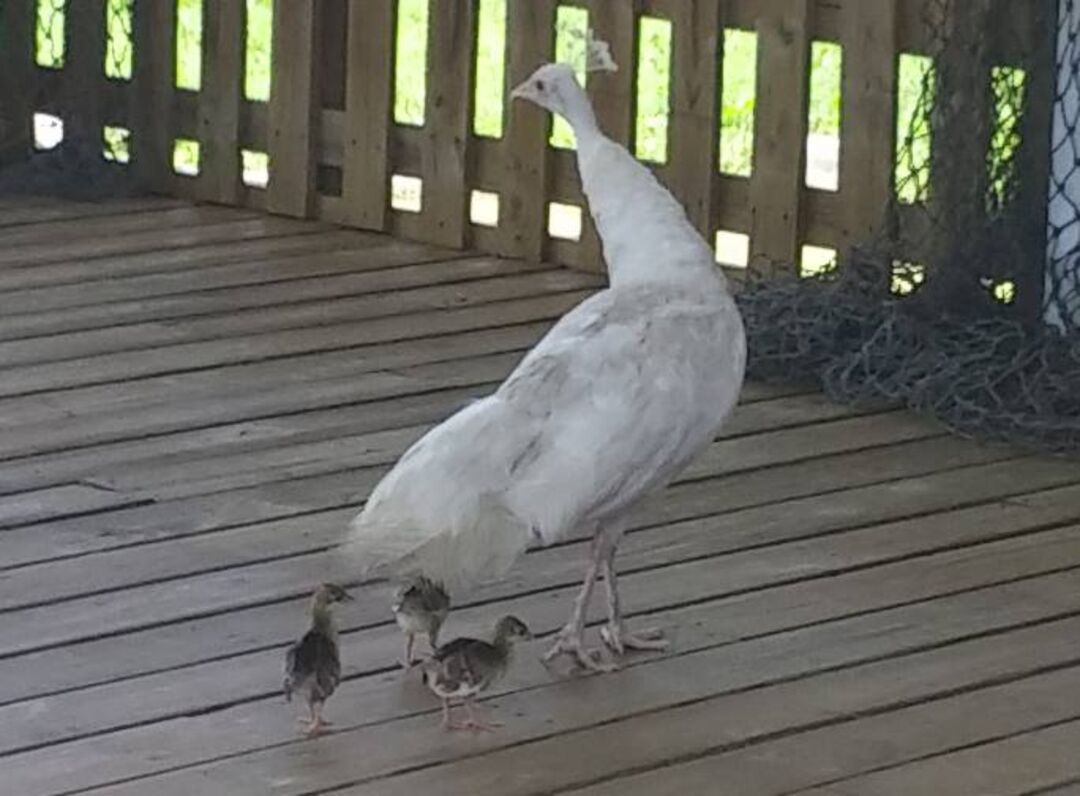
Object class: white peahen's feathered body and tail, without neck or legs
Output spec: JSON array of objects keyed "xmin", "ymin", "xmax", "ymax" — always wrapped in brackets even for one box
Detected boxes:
[{"xmin": 347, "ymin": 284, "xmax": 745, "ymax": 585}]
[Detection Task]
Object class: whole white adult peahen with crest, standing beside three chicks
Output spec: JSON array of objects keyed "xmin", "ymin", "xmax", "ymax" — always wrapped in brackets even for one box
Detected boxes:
[{"xmin": 345, "ymin": 39, "xmax": 746, "ymax": 670}]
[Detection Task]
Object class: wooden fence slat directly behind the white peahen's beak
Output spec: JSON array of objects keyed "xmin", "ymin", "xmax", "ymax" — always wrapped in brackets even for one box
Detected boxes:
[{"xmin": 496, "ymin": 0, "xmax": 557, "ymax": 260}]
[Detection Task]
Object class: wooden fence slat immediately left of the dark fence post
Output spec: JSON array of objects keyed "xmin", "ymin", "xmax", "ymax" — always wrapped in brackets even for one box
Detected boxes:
[{"xmin": 267, "ymin": 0, "xmax": 322, "ymax": 217}]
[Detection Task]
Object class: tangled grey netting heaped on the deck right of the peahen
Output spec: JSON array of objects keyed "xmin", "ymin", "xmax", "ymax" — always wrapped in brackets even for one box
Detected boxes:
[{"xmin": 739, "ymin": 257, "xmax": 1080, "ymax": 456}]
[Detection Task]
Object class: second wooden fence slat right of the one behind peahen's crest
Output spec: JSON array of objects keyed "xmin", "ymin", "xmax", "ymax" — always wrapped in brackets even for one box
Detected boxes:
[{"xmin": 751, "ymin": 0, "xmax": 812, "ymax": 268}]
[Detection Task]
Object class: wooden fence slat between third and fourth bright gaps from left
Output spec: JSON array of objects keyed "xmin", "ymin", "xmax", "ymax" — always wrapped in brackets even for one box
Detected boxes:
[{"xmin": 195, "ymin": 0, "xmax": 246, "ymax": 204}]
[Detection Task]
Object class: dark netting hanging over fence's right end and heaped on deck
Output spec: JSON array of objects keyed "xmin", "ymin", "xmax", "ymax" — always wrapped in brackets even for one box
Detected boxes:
[{"xmin": 740, "ymin": 0, "xmax": 1080, "ymax": 455}]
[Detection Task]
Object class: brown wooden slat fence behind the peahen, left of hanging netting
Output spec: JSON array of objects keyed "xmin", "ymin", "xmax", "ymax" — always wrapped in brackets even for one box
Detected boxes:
[{"xmin": 0, "ymin": 0, "xmax": 1049, "ymax": 278}]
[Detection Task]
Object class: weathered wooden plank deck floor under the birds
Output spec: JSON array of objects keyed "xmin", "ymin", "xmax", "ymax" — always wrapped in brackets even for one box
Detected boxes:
[{"xmin": 0, "ymin": 200, "xmax": 1080, "ymax": 796}]
